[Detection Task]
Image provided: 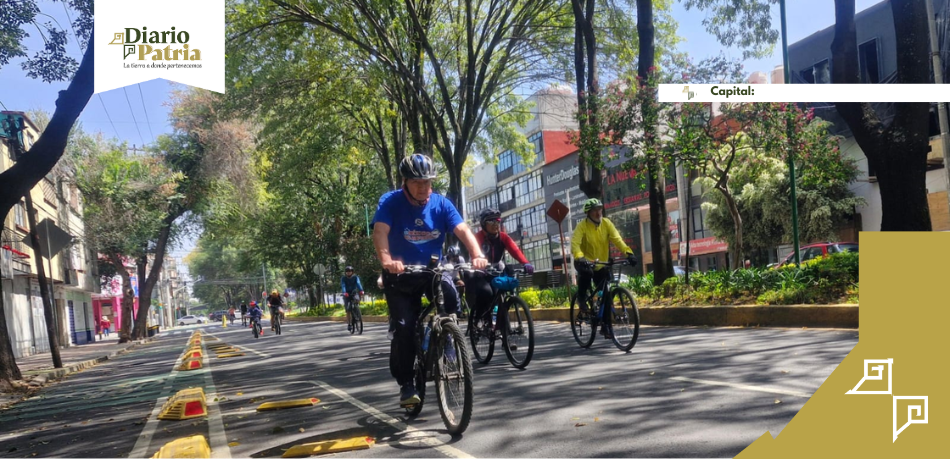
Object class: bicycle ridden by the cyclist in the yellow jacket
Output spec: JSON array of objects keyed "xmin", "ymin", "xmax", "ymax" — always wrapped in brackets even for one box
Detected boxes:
[{"xmin": 571, "ymin": 260, "xmax": 640, "ymax": 352}]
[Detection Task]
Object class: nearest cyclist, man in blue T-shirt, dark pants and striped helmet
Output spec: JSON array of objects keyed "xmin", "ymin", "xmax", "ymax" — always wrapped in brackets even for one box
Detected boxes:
[{"xmin": 373, "ymin": 154, "xmax": 488, "ymax": 406}]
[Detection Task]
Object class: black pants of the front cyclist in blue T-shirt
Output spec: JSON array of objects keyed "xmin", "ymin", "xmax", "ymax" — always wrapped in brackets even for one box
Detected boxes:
[{"xmin": 383, "ymin": 273, "xmax": 459, "ymax": 386}]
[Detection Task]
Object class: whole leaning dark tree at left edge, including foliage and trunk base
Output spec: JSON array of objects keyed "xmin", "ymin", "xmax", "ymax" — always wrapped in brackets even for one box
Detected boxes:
[{"xmin": 0, "ymin": 0, "xmax": 94, "ymax": 386}]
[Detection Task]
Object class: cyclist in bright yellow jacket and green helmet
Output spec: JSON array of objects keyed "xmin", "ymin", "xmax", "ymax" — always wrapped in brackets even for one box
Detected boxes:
[{"xmin": 571, "ymin": 198, "xmax": 637, "ymax": 313}]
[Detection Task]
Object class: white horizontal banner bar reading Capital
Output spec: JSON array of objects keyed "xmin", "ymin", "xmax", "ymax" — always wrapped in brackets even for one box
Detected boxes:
[{"xmin": 657, "ymin": 83, "xmax": 950, "ymax": 102}]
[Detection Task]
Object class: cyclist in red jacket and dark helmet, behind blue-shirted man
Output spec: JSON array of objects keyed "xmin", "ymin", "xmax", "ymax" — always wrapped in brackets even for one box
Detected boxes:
[{"xmin": 465, "ymin": 208, "xmax": 534, "ymax": 324}]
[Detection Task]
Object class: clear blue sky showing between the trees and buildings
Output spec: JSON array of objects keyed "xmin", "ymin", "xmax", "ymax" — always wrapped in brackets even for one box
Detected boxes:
[{"xmin": 0, "ymin": 0, "xmax": 879, "ymax": 269}]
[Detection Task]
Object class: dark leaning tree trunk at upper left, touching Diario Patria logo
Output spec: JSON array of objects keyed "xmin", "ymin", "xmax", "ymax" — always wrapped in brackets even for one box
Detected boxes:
[{"xmin": 0, "ymin": 30, "xmax": 95, "ymax": 219}]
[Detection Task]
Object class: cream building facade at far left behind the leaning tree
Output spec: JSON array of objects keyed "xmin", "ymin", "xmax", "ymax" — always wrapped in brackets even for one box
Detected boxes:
[{"xmin": 0, "ymin": 112, "xmax": 99, "ymax": 357}]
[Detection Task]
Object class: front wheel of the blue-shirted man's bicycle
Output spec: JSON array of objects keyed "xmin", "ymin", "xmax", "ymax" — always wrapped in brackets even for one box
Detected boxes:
[{"xmin": 435, "ymin": 322, "xmax": 474, "ymax": 435}]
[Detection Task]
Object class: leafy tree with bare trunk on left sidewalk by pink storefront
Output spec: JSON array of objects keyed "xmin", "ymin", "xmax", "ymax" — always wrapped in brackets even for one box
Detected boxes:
[{"xmin": 76, "ymin": 146, "xmax": 180, "ymax": 342}]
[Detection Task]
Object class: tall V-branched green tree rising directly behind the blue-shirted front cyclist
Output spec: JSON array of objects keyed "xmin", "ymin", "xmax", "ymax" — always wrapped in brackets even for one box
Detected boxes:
[{"xmin": 232, "ymin": 0, "xmax": 567, "ymax": 208}]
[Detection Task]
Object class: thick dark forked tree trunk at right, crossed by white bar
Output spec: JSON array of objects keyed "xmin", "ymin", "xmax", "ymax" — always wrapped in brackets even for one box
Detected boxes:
[{"xmin": 831, "ymin": 0, "xmax": 932, "ymax": 231}]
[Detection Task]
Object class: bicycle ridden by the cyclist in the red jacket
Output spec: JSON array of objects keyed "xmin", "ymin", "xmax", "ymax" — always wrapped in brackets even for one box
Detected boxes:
[{"xmin": 468, "ymin": 269, "xmax": 534, "ymax": 369}]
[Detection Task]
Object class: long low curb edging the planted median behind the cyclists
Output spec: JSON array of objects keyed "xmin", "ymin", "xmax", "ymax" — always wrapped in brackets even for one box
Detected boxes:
[{"xmin": 287, "ymin": 304, "xmax": 858, "ymax": 329}]
